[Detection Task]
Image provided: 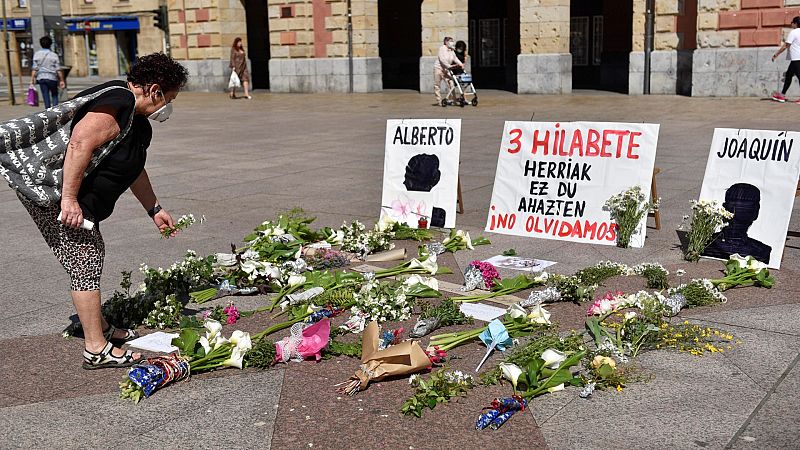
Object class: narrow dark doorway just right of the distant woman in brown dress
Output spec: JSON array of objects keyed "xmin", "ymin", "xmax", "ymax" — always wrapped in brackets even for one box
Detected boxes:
[{"xmin": 245, "ymin": 0, "xmax": 269, "ymax": 89}]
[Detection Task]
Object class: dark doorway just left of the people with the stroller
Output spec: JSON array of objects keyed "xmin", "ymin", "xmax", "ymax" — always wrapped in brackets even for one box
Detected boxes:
[{"xmin": 378, "ymin": 0, "xmax": 422, "ymax": 91}]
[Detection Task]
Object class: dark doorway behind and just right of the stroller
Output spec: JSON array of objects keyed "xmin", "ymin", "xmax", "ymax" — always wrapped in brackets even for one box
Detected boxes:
[{"xmin": 467, "ymin": 0, "xmax": 520, "ymax": 92}]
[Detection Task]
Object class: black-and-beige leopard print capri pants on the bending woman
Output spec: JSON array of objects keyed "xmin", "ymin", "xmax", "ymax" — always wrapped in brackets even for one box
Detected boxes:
[{"xmin": 17, "ymin": 194, "xmax": 106, "ymax": 291}]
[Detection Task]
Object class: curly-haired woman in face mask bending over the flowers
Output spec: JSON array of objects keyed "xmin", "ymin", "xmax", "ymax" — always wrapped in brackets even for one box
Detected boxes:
[{"xmin": 0, "ymin": 53, "xmax": 188, "ymax": 369}]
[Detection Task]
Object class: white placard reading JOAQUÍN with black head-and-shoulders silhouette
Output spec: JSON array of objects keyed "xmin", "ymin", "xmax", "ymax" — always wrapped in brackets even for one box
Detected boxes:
[{"xmin": 700, "ymin": 128, "xmax": 800, "ymax": 269}]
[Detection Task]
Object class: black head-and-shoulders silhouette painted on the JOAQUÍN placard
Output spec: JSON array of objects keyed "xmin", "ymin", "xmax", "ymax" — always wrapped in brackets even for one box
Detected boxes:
[{"xmin": 703, "ymin": 183, "xmax": 772, "ymax": 264}]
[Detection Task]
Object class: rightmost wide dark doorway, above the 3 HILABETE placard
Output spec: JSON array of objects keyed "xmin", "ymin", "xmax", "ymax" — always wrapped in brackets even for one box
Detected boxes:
[{"xmin": 569, "ymin": 0, "xmax": 633, "ymax": 94}]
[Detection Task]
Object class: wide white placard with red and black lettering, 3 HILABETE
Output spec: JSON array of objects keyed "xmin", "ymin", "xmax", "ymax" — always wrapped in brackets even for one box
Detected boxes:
[{"xmin": 486, "ymin": 122, "xmax": 659, "ymax": 247}]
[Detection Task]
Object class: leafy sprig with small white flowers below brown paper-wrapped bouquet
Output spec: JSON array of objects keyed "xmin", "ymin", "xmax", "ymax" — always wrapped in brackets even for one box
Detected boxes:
[{"xmin": 400, "ymin": 367, "xmax": 475, "ymax": 417}]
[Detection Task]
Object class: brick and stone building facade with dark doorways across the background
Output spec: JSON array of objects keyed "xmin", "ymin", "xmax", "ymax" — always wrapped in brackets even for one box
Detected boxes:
[{"xmin": 12, "ymin": 0, "xmax": 788, "ymax": 96}]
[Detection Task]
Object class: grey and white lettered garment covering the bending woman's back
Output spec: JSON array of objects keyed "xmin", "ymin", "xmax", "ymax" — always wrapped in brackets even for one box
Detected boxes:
[{"xmin": 0, "ymin": 86, "xmax": 133, "ymax": 206}]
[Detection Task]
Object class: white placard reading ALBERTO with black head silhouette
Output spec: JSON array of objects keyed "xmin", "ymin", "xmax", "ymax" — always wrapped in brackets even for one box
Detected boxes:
[{"xmin": 381, "ymin": 119, "xmax": 461, "ymax": 228}]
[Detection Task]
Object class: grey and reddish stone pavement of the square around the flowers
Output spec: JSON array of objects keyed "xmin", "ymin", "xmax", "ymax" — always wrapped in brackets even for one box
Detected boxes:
[{"xmin": 0, "ymin": 91, "xmax": 800, "ymax": 449}]
